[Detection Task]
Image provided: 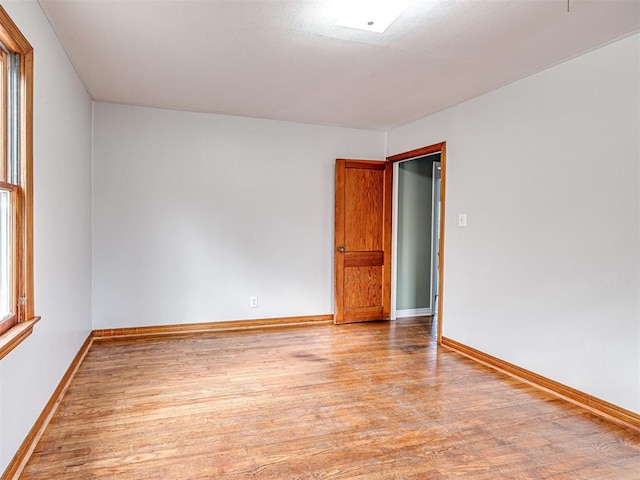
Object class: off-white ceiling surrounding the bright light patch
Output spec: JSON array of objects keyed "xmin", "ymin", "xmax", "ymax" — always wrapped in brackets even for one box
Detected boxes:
[{"xmin": 39, "ymin": 0, "xmax": 640, "ymax": 130}]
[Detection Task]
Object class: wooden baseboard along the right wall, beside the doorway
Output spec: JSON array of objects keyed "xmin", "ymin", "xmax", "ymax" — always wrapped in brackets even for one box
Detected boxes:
[{"xmin": 441, "ymin": 337, "xmax": 640, "ymax": 431}]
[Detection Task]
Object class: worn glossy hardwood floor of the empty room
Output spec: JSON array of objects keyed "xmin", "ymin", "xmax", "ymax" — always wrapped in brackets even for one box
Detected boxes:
[{"xmin": 21, "ymin": 319, "xmax": 640, "ymax": 480}]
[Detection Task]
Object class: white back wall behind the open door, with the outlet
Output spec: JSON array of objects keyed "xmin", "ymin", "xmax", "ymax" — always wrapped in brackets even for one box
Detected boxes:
[{"xmin": 93, "ymin": 103, "xmax": 384, "ymax": 329}]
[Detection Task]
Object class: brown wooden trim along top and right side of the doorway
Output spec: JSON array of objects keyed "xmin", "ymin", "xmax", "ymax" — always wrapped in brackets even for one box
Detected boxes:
[{"xmin": 387, "ymin": 142, "xmax": 447, "ymax": 345}]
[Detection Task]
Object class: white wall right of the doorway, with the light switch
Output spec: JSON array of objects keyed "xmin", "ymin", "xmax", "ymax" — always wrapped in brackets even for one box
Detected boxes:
[{"xmin": 388, "ymin": 35, "xmax": 640, "ymax": 412}]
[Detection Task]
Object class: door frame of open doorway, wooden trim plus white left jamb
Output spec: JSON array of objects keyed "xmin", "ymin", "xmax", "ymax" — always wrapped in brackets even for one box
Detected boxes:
[{"xmin": 386, "ymin": 142, "xmax": 447, "ymax": 345}]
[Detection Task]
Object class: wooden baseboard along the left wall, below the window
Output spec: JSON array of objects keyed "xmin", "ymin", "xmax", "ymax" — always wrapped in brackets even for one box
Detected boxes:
[{"xmin": 2, "ymin": 334, "xmax": 93, "ymax": 480}]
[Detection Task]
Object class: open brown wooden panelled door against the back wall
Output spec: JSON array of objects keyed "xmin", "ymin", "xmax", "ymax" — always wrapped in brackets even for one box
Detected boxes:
[{"xmin": 335, "ymin": 159, "xmax": 392, "ymax": 323}]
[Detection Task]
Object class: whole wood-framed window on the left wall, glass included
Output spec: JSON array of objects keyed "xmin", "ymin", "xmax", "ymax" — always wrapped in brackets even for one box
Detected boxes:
[{"xmin": 0, "ymin": 7, "xmax": 39, "ymax": 358}]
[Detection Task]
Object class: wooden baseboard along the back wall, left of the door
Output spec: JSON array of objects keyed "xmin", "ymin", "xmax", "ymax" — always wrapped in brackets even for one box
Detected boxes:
[{"xmin": 93, "ymin": 314, "xmax": 333, "ymax": 340}]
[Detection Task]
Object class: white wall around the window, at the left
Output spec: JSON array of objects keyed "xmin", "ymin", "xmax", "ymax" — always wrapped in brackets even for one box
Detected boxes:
[{"xmin": 0, "ymin": 1, "xmax": 91, "ymax": 472}]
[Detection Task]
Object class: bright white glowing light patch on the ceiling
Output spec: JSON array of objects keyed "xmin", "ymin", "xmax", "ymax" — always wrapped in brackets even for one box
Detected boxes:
[{"xmin": 335, "ymin": 0, "xmax": 406, "ymax": 33}]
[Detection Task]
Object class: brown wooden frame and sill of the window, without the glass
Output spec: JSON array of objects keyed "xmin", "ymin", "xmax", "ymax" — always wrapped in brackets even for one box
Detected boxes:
[{"xmin": 0, "ymin": 6, "xmax": 40, "ymax": 359}]
